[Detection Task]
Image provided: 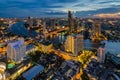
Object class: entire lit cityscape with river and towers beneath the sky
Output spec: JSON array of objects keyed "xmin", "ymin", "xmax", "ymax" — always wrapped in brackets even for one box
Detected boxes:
[{"xmin": 0, "ymin": 10, "xmax": 120, "ymax": 80}]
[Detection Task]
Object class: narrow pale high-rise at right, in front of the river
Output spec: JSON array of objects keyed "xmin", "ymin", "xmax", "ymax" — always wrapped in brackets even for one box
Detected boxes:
[{"xmin": 97, "ymin": 47, "xmax": 105, "ymax": 63}]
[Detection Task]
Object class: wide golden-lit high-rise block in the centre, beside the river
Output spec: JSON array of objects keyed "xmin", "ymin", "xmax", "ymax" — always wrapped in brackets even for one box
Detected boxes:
[{"xmin": 65, "ymin": 34, "xmax": 83, "ymax": 56}]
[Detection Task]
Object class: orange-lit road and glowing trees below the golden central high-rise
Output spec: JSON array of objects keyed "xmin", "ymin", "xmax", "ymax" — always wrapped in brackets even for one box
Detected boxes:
[{"xmin": 47, "ymin": 49, "xmax": 95, "ymax": 79}]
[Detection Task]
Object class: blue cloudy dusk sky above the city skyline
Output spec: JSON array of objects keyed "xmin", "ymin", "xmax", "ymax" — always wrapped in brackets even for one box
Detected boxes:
[{"xmin": 0, "ymin": 0, "xmax": 120, "ymax": 17}]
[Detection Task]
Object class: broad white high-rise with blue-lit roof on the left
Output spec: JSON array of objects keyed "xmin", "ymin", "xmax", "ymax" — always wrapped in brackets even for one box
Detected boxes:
[{"xmin": 7, "ymin": 38, "xmax": 26, "ymax": 62}]
